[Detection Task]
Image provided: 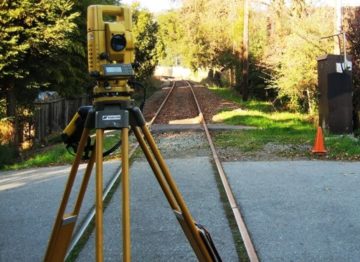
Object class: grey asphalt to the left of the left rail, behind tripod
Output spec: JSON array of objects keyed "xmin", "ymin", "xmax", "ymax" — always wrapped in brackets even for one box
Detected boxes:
[{"xmin": 0, "ymin": 161, "xmax": 119, "ymax": 262}]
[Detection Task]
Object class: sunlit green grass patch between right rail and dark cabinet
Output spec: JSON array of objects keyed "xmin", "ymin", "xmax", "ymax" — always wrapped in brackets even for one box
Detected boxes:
[{"xmin": 213, "ymin": 109, "xmax": 314, "ymax": 152}]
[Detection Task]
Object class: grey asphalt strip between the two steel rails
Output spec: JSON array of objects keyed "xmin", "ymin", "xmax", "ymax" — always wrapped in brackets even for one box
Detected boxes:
[{"xmin": 77, "ymin": 157, "xmax": 238, "ymax": 262}]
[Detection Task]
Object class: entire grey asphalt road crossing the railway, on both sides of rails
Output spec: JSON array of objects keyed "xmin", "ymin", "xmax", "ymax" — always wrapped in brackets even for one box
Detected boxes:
[{"xmin": 0, "ymin": 157, "xmax": 360, "ymax": 262}]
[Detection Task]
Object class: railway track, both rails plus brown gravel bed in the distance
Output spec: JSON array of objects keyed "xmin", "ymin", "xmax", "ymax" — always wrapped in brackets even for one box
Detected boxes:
[{"xmin": 67, "ymin": 81, "xmax": 259, "ymax": 261}]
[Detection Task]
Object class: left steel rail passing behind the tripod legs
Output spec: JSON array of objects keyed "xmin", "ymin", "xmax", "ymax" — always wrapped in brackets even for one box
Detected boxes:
[{"xmin": 65, "ymin": 81, "xmax": 176, "ymax": 260}]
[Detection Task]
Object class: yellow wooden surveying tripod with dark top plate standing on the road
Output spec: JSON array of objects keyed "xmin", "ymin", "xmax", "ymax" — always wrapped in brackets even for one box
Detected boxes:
[{"xmin": 44, "ymin": 100, "xmax": 221, "ymax": 262}]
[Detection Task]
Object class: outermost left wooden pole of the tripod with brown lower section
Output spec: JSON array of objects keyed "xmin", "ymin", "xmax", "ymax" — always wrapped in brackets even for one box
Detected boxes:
[{"xmin": 44, "ymin": 128, "xmax": 92, "ymax": 262}]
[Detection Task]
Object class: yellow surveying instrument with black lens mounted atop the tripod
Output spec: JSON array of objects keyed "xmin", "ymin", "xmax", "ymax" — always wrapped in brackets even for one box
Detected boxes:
[{"xmin": 87, "ymin": 5, "xmax": 134, "ymax": 106}]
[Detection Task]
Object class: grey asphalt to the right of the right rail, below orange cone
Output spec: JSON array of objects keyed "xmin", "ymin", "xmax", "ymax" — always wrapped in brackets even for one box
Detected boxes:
[{"xmin": 224, "ymin": 161, "xmax": 360, "ymax": 262}]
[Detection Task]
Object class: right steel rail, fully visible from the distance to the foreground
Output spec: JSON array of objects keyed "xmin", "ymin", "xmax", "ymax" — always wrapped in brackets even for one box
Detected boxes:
[{"xmin": 186, "ymin": 81, "xmax": 259, "ymax": 262}]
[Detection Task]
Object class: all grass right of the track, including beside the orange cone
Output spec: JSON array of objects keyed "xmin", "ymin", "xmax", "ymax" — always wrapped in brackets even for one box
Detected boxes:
[{"xmin": 210, "ymin": 87, "xmax": 360, "ymax": 160}]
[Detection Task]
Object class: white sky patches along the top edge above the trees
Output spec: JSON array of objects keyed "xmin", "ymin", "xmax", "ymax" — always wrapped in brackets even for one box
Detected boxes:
[{"xmin": 121, "ymin": 0, "xmax": 360, "ymax": 13}]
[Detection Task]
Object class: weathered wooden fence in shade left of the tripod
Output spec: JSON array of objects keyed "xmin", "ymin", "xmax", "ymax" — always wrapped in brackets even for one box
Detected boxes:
[{"xmin": 34, "ymin": 96, "xmax": 89, "ymax": 143}]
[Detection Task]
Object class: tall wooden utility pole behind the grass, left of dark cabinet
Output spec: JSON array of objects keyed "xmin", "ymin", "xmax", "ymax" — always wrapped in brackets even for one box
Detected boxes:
[{"xmin": 241, "ymin": 0, "xmax": 249, "ymax": 101}]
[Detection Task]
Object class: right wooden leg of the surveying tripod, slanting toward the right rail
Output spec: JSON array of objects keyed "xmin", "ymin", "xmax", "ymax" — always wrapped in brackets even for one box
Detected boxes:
[{"xmin": 135, "ymin": 125, "xmax": 213, "ymax": 262}]
